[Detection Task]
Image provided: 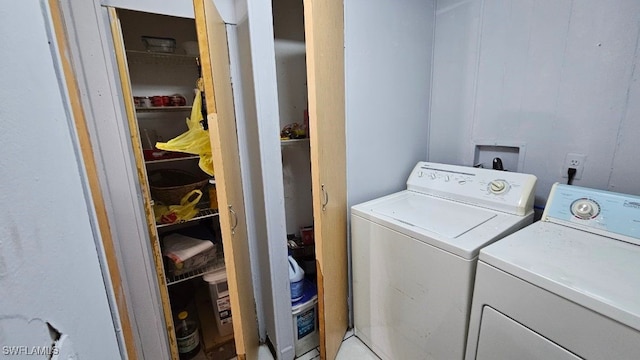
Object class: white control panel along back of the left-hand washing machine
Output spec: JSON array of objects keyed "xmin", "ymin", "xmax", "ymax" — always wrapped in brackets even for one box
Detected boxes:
[{"xmin": 407, "ymin": 162, "xmax": 537, "ymax": 215}]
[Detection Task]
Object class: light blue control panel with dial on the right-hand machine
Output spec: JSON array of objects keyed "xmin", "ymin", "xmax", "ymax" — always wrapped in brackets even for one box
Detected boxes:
[{"xmin": 542, "ymin": 183, "xmax": 640, "ymax": 245}]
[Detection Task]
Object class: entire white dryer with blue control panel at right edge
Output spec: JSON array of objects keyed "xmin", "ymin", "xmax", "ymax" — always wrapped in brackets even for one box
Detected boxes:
[{"xmin": 466, "ymin": 184, "xmax": 640, "ymax": 360}]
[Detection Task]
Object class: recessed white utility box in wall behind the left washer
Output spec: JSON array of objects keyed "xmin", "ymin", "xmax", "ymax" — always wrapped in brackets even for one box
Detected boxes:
[{"xmin": 473, "ymin": 141, "xmax": 525, "ymax": 172}]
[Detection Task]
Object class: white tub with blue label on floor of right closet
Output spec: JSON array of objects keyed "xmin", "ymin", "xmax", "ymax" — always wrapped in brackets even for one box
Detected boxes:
[{"xmin": 291, "ymin": 280, "xmax": 319, "ymax": 357}]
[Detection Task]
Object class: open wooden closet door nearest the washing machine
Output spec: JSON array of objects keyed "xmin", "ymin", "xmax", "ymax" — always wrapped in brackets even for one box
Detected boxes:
[{"xmin": 304, "ymin": 0, "xmax": 348, "ymax": 359}]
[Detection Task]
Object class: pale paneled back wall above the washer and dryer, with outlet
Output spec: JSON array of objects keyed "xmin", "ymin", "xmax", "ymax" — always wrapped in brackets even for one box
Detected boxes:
[{"xmin": 429, "ymin": 0, "xmax": 640, "ymax": 206}]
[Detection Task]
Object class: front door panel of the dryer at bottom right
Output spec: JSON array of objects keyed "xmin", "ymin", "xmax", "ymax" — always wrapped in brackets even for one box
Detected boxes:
[{"xmin": 476, "ymin": 306, "xmax": 581, "ymax": 360}]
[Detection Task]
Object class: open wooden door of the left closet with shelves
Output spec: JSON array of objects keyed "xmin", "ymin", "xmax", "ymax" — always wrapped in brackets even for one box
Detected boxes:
[{"xmin": 193, "ymin": 0, "xmax": 259, "ymax": 360}]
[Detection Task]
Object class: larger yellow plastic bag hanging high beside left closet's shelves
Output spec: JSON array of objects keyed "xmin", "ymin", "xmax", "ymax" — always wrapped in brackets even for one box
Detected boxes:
[{"xmin": 156, "ymin": 89, "xmax": 213, "ymax": 176}]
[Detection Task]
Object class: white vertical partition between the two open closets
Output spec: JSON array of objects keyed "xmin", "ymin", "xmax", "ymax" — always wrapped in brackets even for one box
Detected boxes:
[{"xmin": 231, "ymin": 0, "xmax": 294, "ymax": 359}]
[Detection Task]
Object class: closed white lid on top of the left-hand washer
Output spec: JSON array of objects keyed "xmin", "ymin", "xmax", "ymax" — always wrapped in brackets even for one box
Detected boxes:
[{"xmin": 370, "ymin": 191, "xmax": 496, "ymax": 239}]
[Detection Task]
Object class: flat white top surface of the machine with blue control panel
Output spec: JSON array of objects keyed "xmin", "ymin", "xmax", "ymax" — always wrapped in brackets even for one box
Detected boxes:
[{"xmin": 480, "ymin": 222, "xmax": 640, "ymax": 330}]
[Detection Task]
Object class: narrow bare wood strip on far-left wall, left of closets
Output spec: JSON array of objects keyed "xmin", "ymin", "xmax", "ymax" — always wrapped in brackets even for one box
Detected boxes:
[{"xmin": 48, "ymin": 0, "xmax": 137, "ymax": 359}]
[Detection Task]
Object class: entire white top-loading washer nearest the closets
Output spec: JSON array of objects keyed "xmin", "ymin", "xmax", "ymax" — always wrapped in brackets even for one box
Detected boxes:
[{"xmin": 351, "ymin": 162, "xmax": 536, "ymax": 360}]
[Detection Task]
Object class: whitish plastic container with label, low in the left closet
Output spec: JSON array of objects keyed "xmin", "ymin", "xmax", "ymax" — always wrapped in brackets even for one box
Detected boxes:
[{"xmin": 202, "ymin": 268, "xmax": 233, "ymax": 336}]
